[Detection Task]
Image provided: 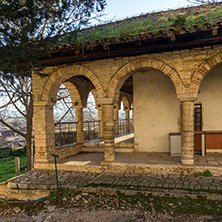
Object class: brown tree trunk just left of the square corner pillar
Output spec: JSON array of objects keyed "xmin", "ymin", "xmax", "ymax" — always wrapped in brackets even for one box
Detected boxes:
[{"xmin": 26, "ymin": 94, "xmax": 33, "ymax": 171}]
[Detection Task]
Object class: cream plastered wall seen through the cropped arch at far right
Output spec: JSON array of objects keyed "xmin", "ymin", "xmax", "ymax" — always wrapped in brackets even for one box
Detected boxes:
[{"xmin": 195, "ymin": 64, "xmax": 222, "ymax": 131}]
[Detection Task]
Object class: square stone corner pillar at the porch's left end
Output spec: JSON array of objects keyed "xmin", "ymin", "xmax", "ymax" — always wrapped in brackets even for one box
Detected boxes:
[{"xmin": 33, "ymin": 101, "xmax": 55, "ymax": 163}]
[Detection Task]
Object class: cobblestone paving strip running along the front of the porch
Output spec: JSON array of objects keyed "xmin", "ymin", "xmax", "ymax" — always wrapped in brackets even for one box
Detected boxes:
[{"xmin": 10, "ymin": 169, "xmax": 222, "ymax": 194}]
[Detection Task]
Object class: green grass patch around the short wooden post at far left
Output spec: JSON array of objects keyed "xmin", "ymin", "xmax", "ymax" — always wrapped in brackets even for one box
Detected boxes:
[{"xmin": 0, "ymin": 148, "xmax": 27, "ymax": 182}]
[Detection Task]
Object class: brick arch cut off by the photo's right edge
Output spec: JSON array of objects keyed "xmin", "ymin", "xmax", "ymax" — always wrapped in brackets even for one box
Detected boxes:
[{"xmin": 190, "ymin": 52, "xmax": 222, "ymax": 94}]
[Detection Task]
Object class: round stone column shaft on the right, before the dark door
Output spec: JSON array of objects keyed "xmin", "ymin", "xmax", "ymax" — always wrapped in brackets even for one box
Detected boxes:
[{"xmin": 181, "ymin": 101, "xmax": 194, "ymax": 165}]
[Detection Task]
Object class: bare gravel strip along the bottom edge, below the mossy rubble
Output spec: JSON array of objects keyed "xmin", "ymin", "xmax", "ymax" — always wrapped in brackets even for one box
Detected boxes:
[{"xmin": 0, "ymin": 206, "xmax": 219, "ymax": 222}]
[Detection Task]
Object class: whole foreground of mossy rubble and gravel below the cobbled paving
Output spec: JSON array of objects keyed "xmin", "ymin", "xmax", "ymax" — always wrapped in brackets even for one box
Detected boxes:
[{"xmin": 0, "ymin": 190, "xmax": 222, "ymax": 222}]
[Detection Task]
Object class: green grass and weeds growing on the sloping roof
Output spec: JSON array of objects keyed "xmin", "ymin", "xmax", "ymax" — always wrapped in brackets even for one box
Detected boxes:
[{"xmin": 59, "ymin": 4, "xmax": 222, "ymax": 46}]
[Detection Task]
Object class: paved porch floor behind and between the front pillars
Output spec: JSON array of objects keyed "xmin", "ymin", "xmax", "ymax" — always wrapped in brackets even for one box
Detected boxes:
[{"xmin": 58, "ymin": 153, "xmax": 222, "ymax": 167}]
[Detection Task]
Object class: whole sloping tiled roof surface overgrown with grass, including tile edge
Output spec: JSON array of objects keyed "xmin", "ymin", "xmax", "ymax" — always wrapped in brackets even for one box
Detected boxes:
[{"xmin": 52, "ymin": 3, "xmax": 222, "ymax": 51}]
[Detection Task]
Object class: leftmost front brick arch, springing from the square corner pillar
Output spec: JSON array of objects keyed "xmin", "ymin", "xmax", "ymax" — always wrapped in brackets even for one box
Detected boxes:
[{"xmin": 41, "ymin": 65, "xmax": 104, "ymax": 101}]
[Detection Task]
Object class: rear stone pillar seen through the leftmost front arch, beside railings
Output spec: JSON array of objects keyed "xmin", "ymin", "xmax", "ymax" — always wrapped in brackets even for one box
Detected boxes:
[{"xmin": 75, "ymin": 107, "xmax": 84, "ymax": 143}]
